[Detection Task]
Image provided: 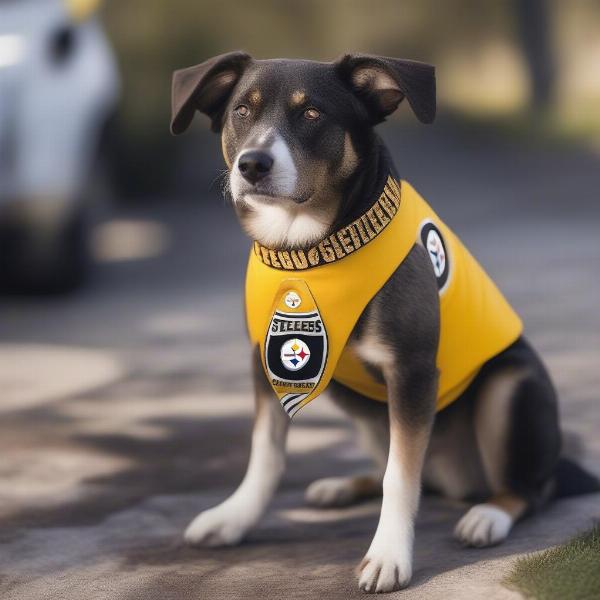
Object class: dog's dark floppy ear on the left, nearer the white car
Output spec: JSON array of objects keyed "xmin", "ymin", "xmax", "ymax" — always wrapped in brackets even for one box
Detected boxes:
[{"xmin": 171, "ymin": 52, "xmax": 251, "ymax": 135}]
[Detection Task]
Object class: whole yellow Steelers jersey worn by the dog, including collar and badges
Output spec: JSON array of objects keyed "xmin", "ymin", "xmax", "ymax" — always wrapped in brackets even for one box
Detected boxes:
[{"xmin": 246, "ymin": 176, "xmax": 523, "ymax": 417}]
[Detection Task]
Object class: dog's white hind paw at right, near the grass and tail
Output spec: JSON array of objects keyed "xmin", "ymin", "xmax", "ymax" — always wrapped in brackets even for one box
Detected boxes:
[{"xmin": 454, "ymin": 504, "xmax": 513, "ymax": 548}]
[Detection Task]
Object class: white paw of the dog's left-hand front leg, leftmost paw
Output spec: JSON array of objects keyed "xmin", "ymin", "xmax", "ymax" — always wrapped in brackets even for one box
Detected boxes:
[{"xmin": 183, "ymin": 503, "xmax": 251, "ymax": 547}]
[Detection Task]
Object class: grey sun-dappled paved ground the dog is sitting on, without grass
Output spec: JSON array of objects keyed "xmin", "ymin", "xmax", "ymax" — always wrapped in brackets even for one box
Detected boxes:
[{"xmin": 0, "ymin": 124, "xmax": 600, "ymax": 600}]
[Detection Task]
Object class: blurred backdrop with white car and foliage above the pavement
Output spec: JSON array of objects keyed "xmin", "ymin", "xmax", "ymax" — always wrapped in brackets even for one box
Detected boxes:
[{"xmin": 0, "ymin": 0, "xmax": 600, "ymax": 291}]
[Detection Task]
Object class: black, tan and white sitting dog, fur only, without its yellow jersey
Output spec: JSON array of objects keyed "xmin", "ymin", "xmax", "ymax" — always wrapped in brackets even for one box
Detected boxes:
[{"xmin": 172, "ymin": 52, "xmax": 598, "ymax": 592}]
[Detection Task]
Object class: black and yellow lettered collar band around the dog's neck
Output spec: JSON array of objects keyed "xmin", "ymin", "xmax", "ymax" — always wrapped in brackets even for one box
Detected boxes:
[{"xmin": 253, "ymin": 175, "xmax": 401, "ymax": 271}]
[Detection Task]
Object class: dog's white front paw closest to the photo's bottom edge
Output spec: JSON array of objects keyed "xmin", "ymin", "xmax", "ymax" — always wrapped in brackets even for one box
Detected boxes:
[{"xmin": 358, "ymin": 551, "xmax": 412, "ymax": 594}]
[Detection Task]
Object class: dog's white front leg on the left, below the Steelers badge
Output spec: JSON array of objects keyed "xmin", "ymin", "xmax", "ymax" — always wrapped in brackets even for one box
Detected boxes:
[{"xmin": 185, "ymin": 351, "xmax": 289, "ymax": 546}]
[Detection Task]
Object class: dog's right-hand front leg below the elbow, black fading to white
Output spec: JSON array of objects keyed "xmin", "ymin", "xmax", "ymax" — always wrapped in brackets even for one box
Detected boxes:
[{"xmin": 359, "ymin": 365, "xmax": 437, "ymax": 592}]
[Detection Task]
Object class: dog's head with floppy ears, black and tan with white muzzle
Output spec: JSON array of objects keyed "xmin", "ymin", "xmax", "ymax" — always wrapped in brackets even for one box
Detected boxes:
[{"xmin": 171, "ymin": 52, "xmax": 435, "ymax": 248}]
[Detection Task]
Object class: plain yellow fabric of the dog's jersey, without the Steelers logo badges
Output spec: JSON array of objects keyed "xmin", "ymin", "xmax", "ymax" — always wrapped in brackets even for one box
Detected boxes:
[{"xmin": 246, "ymin": 177, "xmax": 522, "ymax": 410}]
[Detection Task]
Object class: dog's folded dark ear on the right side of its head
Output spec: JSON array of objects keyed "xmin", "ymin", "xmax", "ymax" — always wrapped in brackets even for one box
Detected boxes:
[{"xmin": 334, "ymin": 54, "xmax": 435, "ymax": 124}]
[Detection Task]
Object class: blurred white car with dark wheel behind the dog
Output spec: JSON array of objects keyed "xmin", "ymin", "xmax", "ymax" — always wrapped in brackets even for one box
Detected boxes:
[{"xmin": 0, "ymin": 0, "xmax": 119, "ymax": 292}]
